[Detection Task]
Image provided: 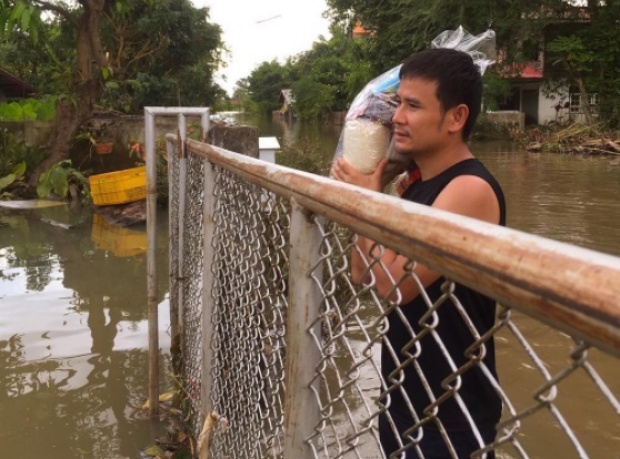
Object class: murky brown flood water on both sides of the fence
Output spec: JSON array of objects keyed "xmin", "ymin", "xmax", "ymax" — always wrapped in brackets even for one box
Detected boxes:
[{"xmin": 0, "ymin": 117, "xmax": 620, "ymax": 459}]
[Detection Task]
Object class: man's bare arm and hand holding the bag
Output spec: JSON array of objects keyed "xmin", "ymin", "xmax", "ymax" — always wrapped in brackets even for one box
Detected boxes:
[{"xmin": 332, "ymin": 160, "xmax": 499, "ymax": 304}]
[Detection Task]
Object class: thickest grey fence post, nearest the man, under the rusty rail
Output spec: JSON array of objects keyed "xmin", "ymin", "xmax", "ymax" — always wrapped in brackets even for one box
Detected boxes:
[{"xmin": 283, "ymin": 199, "xmax": 322, "ymax": 459}]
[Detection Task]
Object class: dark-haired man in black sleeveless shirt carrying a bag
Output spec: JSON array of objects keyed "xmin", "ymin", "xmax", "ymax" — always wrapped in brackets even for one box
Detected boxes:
[{"xmin": 332, "ymin": 49, "xmax": 506, "ymax": 458}]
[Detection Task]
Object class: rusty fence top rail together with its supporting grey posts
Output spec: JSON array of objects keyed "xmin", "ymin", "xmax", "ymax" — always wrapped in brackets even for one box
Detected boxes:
[{"xmin": 166, "ymin": 130, "xmax": 620, "ymax": 458}]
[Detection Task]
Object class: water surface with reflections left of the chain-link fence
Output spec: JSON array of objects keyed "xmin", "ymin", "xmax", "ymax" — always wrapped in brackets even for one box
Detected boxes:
[{"xmin": 0, "ymin": 206, "xmax": 169, "ymax": 459}]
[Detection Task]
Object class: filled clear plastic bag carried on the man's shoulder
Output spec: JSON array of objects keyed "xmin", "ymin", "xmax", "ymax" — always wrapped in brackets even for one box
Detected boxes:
[{"xmin": 332, "ymin": 26, "xmax": 495, "ymax": 174}]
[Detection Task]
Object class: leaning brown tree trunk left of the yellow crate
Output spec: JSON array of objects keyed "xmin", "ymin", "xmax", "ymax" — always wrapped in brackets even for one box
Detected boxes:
[{"xmin": 28, "ymin": 0, "xmax": 105, "ymax": 187}]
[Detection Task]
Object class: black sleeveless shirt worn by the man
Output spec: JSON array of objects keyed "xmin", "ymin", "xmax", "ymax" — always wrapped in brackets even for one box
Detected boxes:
[{"xmin": 381, "ymin": 158, "xmax": 506, "ymax": 431}]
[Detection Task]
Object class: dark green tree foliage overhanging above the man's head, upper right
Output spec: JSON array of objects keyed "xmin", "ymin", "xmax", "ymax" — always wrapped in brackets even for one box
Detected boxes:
[{"xmin": 327, "ymin": 0, "xmax": 620, "ymax": 126}]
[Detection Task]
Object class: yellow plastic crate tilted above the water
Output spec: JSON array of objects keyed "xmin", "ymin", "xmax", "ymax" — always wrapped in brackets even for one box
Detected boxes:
[{"xmin": 88, "ymin": 166, "xmax": 146, "ymax": 206}]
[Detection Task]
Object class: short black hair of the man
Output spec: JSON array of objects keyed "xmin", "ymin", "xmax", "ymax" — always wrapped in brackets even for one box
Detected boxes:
[{"xmin": 399, "ymin": 48, "xmax": 482, "ymax": 140}]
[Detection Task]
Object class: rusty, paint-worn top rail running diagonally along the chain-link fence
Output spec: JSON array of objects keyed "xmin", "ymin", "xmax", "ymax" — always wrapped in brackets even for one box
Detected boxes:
[{"xmin": 187, "ymin": 140, "xmax": 620, "ymax": 356}]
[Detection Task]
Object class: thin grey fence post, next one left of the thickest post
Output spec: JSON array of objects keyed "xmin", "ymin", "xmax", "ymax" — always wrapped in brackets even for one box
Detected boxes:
[{"xmin": 200, "ymin": 162, "xmax": 215, "ymax": 419}]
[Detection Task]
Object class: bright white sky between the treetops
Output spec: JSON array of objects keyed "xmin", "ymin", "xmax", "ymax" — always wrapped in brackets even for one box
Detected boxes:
[{"xmin": 192, "ymin": 0, "xmax": 329, "ymax": 94}]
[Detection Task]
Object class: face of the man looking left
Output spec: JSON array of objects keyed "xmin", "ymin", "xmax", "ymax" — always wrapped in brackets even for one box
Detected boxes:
[{"xmin": 392, "ymin": 78, "xmax": 448, "ymax": 159}]
